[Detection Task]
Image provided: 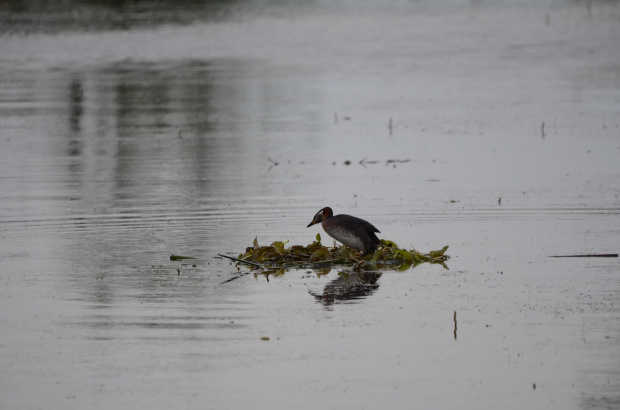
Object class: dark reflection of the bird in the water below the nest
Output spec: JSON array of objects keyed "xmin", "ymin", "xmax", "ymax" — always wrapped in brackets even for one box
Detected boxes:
[{"xmin": 308, "ymin": 271, "xmax": 381, "ymax": 306}]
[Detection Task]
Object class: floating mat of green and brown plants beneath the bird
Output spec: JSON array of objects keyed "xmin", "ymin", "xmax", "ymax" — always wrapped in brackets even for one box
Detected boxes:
[{"xmin": 219, "ymin": 234, "xmax": 450, "ymax": 270}]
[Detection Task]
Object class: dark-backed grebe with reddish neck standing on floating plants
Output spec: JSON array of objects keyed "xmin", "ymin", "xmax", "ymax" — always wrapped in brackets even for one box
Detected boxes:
[{"xmin": 307, "ymin": 207, "xmax": 381, "ymax": 256}]
